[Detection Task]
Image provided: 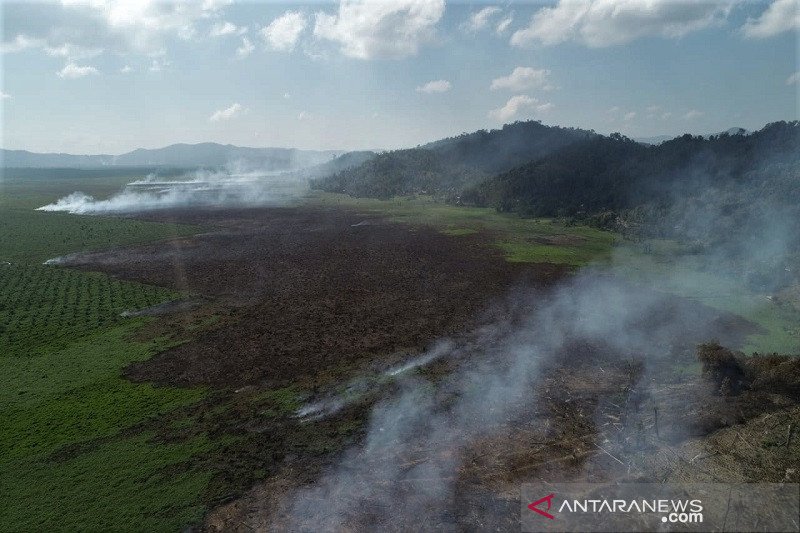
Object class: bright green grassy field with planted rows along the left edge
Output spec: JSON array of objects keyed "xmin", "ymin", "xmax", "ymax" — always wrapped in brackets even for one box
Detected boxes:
[{"xmin": 0, "ymin": 172, "xmax": 212, "ymax": 531}]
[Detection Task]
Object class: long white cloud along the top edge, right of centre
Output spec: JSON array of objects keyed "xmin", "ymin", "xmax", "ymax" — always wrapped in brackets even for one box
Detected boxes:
[{"xmin": 511, "ymin": 0, "xmax": 732, "ymax": 47}]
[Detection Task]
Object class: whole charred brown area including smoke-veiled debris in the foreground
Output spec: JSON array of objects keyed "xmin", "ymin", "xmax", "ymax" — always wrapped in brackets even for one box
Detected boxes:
[{"xmin": 28, "ymin": 202, "xmax": 798, "ymax": 531}]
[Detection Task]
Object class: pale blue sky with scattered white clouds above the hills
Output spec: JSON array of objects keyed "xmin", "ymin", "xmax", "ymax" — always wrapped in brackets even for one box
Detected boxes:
[{"xmin": 0, "ymin": 0, "xmax": 800, "ymax": 154}]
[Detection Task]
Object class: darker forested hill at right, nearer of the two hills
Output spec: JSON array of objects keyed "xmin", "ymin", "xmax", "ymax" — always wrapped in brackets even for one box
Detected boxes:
[{"xmin": 462, "ymin": 121, "xmax": 800, "ymax": 216}]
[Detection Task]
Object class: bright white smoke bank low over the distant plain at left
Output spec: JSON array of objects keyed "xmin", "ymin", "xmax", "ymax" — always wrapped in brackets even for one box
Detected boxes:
[{"xmin": 38, "ymin": 168, "xmax": 308, "ymax": 215}]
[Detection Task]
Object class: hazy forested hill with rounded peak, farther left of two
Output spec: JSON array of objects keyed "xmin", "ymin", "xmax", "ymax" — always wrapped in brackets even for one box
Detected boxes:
[{"xmin": 312, "ymin": 121, "xmax": 597, "ymax": 198}]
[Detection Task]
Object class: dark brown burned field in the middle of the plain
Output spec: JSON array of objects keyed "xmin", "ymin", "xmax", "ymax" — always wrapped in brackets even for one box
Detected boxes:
[{"xmin": 57, "ymin": 208, "xmax": 566, "ymax": 387}]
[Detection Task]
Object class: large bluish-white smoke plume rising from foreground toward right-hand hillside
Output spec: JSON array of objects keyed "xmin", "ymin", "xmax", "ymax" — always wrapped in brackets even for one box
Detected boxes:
[{"xmin": 272, "ymin": 155, "xmax": 798, "ymax": 531}]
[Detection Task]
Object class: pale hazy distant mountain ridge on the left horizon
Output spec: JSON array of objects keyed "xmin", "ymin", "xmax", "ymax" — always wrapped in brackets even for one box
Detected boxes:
[{"xmin": 0, "ymin": 143, "xmax": 344, "ymax": 171}]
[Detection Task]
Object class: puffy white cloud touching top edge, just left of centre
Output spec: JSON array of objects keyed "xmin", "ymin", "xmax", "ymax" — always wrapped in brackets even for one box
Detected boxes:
[{"xmin": 314, "ymin": 0, "xmax": 444, "ymax": 59}]
